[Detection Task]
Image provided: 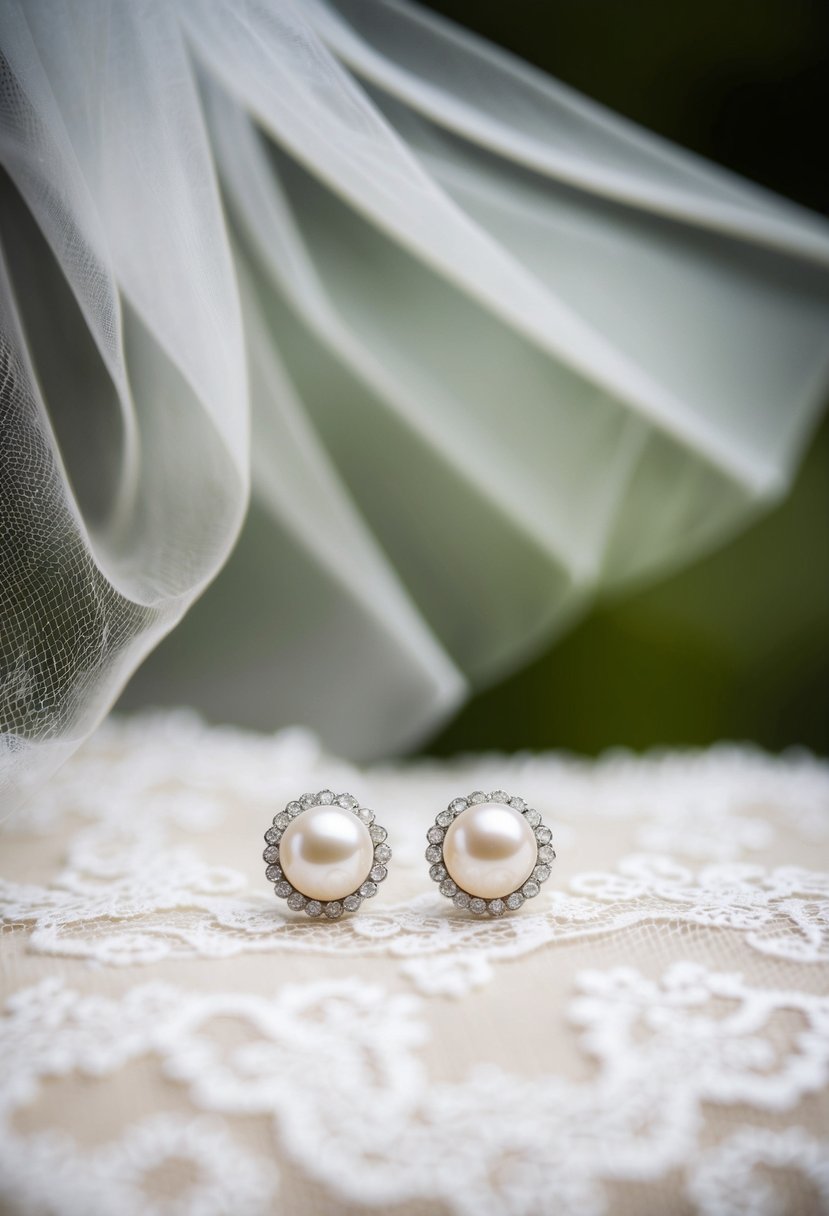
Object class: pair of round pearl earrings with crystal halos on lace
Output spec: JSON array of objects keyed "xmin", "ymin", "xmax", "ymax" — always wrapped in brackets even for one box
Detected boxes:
[{"xmin": 264, "ymin": 789, "xmax": 556, "ymax": 921}]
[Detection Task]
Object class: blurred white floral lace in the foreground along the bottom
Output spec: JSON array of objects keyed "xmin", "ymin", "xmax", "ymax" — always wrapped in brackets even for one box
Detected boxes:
[{"xmin": 0, "ymin": 963, "xmax": 829, "ymax": 1216}]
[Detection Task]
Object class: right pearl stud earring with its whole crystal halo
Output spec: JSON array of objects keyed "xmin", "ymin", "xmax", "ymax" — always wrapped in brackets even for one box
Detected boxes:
[{"xmin": 425, "ymin": 789, "xmax": 556, "ymax": 916}]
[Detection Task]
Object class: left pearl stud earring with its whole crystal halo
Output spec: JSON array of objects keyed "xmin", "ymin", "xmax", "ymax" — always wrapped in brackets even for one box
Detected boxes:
[{"xmin": 263, "ymin": 789, "xmax": 391, "ymax": 921}]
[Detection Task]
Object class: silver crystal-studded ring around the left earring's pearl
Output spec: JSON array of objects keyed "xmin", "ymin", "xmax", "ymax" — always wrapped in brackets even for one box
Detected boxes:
[{"xmin": 263, "ymin": 789, "xmax": 391, "ymax": 921}]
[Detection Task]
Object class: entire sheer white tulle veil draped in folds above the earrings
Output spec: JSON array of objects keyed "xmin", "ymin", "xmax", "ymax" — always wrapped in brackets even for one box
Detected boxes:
[{"xmin": 0, "ymin": 0, "xmax": 829, "ymax": 817}]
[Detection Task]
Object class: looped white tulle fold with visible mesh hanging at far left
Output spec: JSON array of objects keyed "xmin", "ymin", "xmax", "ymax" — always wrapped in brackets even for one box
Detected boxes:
[{"xmin": 0, "ymin": 0, "xmax": 248, "ymax": 801}]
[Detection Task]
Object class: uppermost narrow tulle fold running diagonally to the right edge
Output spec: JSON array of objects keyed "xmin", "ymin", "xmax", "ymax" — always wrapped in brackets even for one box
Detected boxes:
[{"xmin": 306, "ymin": 0, "xmax": 829, "ymax": 264}]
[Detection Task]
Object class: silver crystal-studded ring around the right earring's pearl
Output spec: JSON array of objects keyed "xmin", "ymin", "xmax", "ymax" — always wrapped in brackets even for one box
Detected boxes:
[{"xmin": 425, "ymin": 789, "xmax": 556, "ymax": 917}]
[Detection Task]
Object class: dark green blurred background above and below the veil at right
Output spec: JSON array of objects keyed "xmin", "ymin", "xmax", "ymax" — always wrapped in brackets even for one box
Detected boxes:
[{"xmin": 425, "ymin": 0, "xmax": 829, "ymax": 754}]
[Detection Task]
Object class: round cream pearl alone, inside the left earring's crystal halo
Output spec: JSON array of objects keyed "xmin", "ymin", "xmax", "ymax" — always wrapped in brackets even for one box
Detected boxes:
[{"xmin": 280, "ymin": 806, "xmax": 374, "ymax": 900}]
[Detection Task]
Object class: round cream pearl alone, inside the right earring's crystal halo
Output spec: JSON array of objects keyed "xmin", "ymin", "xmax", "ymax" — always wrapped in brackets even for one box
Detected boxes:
[{"xmin": 444, "ymin": 803, "xmax": 538, "ymax": 900}]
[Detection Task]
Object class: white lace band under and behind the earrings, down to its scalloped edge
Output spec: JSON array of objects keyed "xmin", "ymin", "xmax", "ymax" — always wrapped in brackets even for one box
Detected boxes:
[{"xmin": 0, "ymin": 714, "xmax": 829, "ymax": 996}]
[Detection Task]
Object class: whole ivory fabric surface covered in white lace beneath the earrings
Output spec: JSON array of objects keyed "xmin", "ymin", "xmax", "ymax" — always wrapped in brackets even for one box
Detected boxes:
[{"xmin": 0, "ymin": 711, "xmax": 829, "ymax": 1216}]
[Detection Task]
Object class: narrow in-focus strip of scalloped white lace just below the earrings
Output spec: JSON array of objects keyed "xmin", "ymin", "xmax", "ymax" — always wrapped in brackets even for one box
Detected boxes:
[{"xmin": 0, "ymin": 829, "xmax": 829, "ymax": 996}]
